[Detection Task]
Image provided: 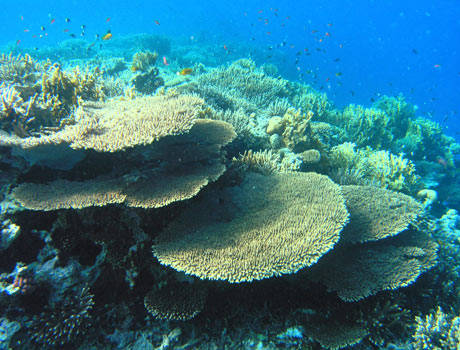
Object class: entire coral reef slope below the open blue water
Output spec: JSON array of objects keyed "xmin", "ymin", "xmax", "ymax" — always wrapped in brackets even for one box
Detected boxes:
[{"xmin": 0, "ymin": 36, "xmax": 460, "ymax": 350}]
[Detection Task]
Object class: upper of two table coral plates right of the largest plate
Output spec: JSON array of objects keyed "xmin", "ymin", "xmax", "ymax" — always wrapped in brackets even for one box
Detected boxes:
[{"xmin": 340, "ymin": 185, "xmax": 423, "ymax": 243}]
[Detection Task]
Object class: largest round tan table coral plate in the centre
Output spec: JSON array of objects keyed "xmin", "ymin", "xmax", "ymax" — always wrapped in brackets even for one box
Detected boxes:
[{"xmin": 153, "ymin": 173, "xmax": 348, "ymax": 283}]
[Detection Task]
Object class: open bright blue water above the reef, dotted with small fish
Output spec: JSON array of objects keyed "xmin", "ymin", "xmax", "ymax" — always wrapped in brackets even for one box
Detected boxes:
[{"xmin": 0, "ymin": 0, "xmax": 460, "ymax": 139}]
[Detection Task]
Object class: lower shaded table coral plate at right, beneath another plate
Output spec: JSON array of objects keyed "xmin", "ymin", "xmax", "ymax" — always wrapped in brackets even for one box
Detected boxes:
[{"xmin": 307, "ymin": 231, "xmax": 437, "ymax": 301}]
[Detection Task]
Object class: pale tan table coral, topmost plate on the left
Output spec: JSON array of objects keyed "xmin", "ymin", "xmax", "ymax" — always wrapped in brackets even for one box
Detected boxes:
[{"xmin": 0, "ymin": 95, "xmax": 204, "ymax": 152}]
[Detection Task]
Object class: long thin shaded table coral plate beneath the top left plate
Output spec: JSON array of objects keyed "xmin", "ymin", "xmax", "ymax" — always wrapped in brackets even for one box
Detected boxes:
[{"xmin": 13, "ymin": 164, "xmax": 225, "ymax": 211}]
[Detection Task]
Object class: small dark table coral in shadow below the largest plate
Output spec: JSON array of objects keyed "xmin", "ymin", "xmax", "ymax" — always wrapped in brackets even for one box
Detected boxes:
[{"xmin": 144, "ymin": 282, "xmax": 207, "ymax": 321}]
